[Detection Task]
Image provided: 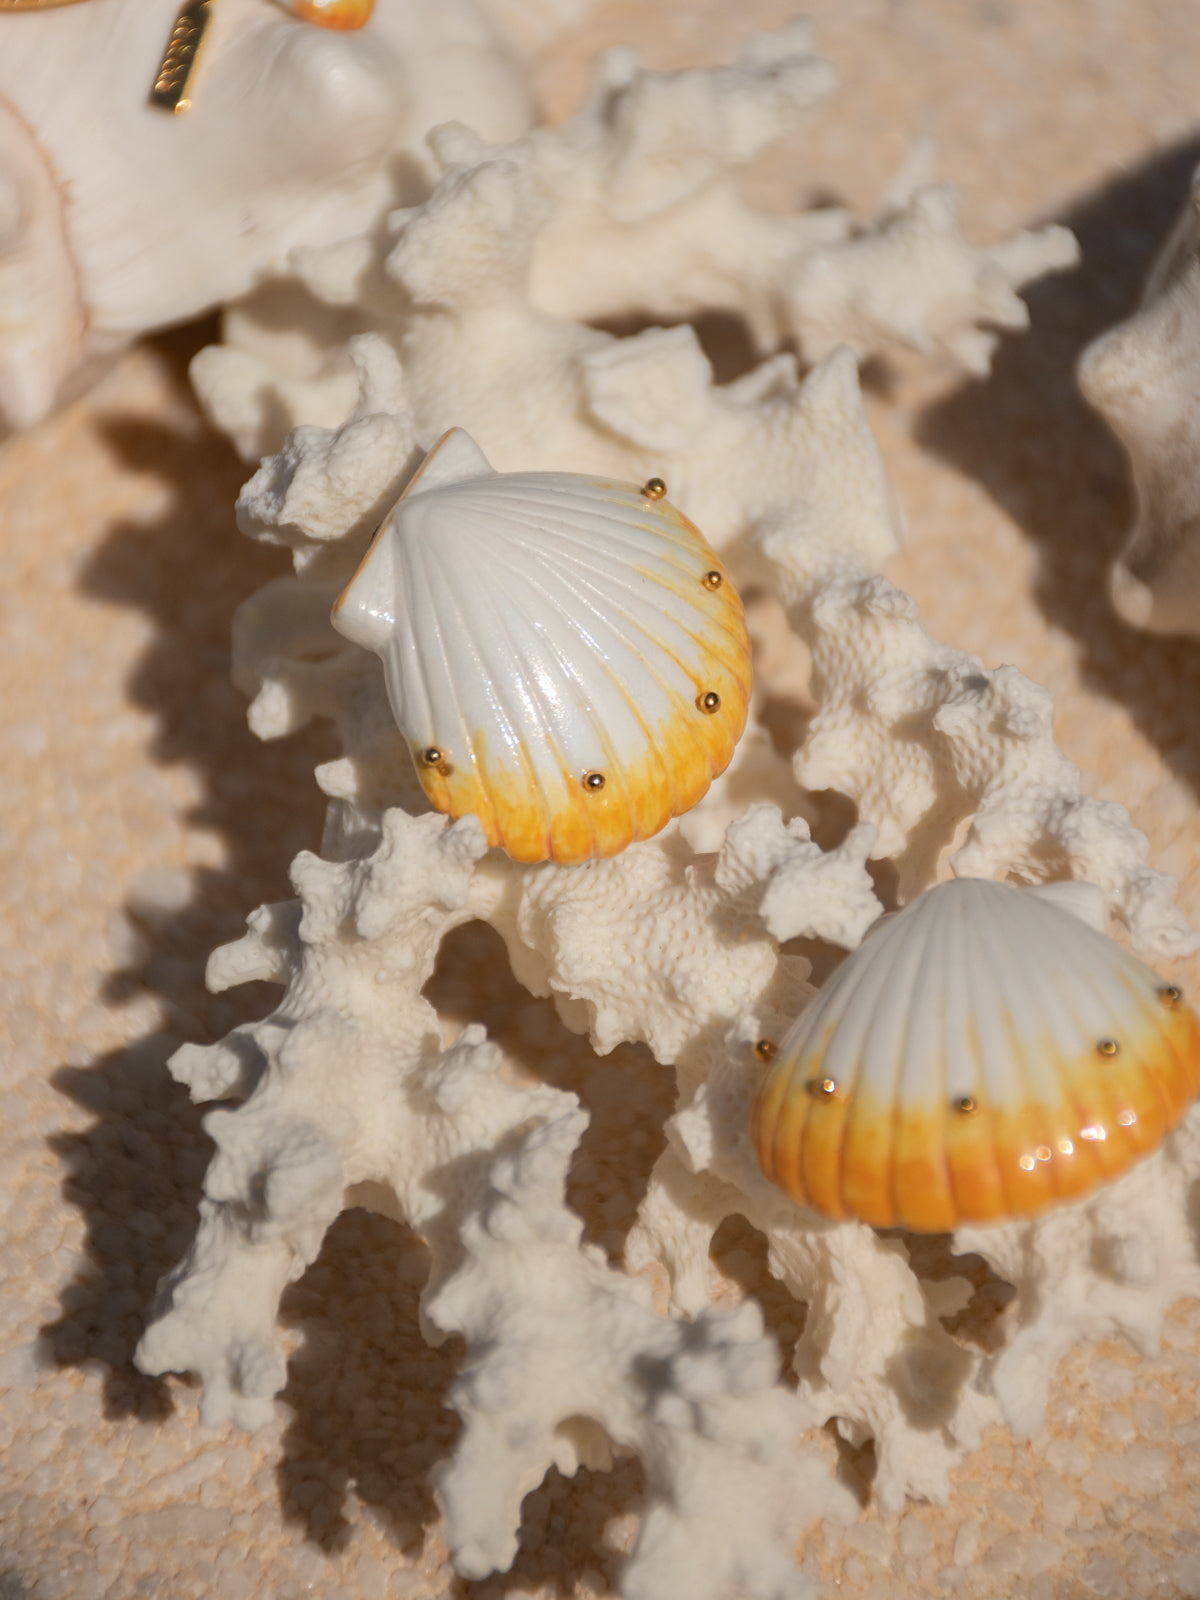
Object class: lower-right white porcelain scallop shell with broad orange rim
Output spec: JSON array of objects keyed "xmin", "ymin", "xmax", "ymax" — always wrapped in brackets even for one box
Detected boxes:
[{"xmin": 750, "ymin": 878, "xmax": 1200, "ymax": 1232}]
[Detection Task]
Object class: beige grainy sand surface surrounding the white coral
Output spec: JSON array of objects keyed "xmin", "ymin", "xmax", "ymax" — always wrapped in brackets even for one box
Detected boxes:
[{"xmin": 0, "ymin": 0, "xmax": 1200, "ymax": 1600}]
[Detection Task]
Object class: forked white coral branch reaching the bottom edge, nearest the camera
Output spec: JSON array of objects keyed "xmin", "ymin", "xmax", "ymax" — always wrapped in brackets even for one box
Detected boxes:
[{"xmin": 424, "ymin": 1112, "xmax": 853, "ymax": 1600}]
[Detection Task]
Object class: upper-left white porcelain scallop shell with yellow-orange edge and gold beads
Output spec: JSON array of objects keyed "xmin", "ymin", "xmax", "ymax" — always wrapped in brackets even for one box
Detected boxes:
[{"xmin": 333, "ymin": 429, "xmax": 750, "ymax": 864}]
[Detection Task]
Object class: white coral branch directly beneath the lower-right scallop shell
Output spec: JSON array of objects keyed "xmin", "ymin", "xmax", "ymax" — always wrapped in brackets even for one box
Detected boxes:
[{"xmin": 640, "ymin": 1036, "xmax": 994, "ymax": 1509}]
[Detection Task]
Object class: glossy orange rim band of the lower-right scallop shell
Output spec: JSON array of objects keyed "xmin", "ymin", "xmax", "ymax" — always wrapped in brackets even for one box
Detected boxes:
[{"xmin": 750, "ymin": 966, "xmax": 1200, "ymax": 1234}]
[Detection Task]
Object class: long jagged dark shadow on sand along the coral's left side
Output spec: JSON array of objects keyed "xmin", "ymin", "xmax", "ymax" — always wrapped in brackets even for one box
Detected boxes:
[{"xmin": 42, "ymin": 322, "xmax": 339, "ymax": 1416}]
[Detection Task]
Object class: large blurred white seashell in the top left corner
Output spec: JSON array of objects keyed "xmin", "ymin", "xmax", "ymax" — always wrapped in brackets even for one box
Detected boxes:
[{"xmin": 0, "ymin": 0, "xmax": 533, "ymax": 435}]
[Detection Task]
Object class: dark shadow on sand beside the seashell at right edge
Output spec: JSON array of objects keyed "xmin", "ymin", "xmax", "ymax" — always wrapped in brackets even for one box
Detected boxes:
[{"xmin": 917, "ymin": 138, "xmax": 1200, "ymax": 794}]
